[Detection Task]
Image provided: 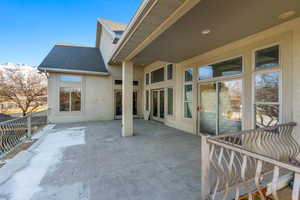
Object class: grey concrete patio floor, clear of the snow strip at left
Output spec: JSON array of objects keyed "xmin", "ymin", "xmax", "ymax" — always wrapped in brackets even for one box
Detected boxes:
[{"xmin": 0, "ymin": 120, "xmax": 200, "ymax": 200}]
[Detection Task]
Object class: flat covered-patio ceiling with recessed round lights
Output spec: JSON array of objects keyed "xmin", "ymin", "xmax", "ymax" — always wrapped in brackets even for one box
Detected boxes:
[{"xmin": 116, "ymin": 0, "xmax": 300, "ymax": 64}]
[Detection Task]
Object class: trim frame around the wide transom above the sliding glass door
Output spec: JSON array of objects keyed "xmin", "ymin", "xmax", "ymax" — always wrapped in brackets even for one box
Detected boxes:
[{"xmin": 196, "ymin": 54, "xmax": 245, "ymax": 83}]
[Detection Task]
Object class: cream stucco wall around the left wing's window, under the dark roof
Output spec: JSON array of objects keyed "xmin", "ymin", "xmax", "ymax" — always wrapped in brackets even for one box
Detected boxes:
[{"xmin": 48, "ymin": 73, "xmax": 114, "ymax": 123}]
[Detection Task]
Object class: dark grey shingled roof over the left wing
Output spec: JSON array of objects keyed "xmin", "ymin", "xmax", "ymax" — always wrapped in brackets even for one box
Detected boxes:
[{"xmin": 38, "ymin": 44, "xmax": 108, "ymax": 74}]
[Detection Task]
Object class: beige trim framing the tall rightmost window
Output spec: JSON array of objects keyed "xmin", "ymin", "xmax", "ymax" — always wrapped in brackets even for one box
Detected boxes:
[{"xmin": 251, "ymin": 42, "xmax": 283, "ymax": 129}]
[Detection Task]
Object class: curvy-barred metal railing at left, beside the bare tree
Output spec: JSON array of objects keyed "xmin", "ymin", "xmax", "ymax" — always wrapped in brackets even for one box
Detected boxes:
[{"xmin": 0, "ymin": 110, "xmax": 48, "ymax": 158}]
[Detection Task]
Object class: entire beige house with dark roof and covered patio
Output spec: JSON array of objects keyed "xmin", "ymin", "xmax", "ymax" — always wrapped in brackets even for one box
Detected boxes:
[{"xmin": 39, "ymin": 0, "xmax": 300, "ymax": 139}]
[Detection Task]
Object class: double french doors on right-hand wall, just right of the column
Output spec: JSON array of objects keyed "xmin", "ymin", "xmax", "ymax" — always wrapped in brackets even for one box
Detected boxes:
[{"xmin": 151, "ymin": 89, "xmax": 165, "ymax": 121}]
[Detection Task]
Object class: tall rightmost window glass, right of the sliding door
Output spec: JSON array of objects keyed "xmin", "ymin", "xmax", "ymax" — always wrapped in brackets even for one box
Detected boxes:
[{"xmin": 254, "ymin": 45, "xmax": 280, "ymax": 128}]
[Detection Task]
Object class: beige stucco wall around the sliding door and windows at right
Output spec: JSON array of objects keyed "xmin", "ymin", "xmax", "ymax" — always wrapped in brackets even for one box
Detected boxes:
[{"xmin": 144, "ymin": 18, "xmax": 300, "ymax": 136}]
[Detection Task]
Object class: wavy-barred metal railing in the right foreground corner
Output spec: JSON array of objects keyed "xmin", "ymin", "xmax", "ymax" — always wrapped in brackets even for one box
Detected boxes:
[{"xmin": 201, "ymin": 123, "xmax": 300, "ymax": 200}]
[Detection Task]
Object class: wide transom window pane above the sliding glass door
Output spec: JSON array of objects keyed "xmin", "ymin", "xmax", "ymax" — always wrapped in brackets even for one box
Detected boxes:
[{"xmin": 198, "ymin": 57, "xmax": 243, "ymax": 80}]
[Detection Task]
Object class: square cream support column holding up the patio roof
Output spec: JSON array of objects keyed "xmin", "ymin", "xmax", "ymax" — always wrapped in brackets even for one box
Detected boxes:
[{"xmin": 122, "ymin": 61, "xmax": 133, "ymax": 136}]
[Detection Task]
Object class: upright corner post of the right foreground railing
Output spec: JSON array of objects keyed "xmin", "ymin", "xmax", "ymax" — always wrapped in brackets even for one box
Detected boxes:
[{"xmin": 201, "ymin": 135, "xmax": 211, "ymax": 200}]
